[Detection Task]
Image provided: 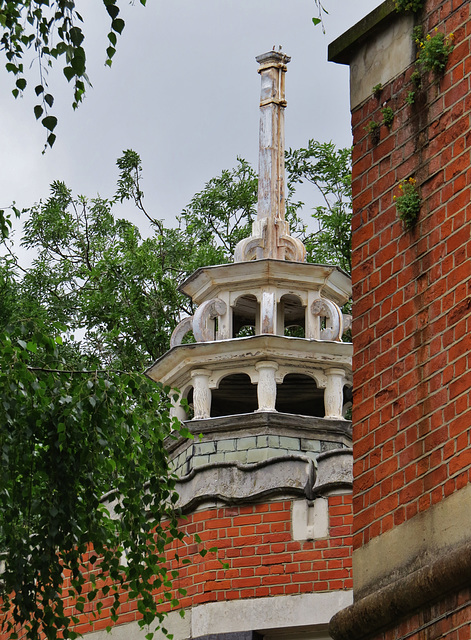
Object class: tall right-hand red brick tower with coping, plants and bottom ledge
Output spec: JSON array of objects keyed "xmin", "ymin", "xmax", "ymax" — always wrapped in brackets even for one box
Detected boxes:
[{"xmin": 329, "ymin": 0, "xmax": 471, "ymax": 640}]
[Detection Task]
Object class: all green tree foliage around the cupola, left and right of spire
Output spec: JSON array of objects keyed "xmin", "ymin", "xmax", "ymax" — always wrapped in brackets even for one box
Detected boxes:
[{"xmin": 0, "ymin": 141, "xmax": 350, "ymax": 640}]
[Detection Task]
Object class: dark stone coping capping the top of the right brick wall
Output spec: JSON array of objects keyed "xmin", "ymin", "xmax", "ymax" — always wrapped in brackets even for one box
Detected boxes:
[{"xmin": 327, "ymin": 0, "xmax": 398, "ymax": 64}]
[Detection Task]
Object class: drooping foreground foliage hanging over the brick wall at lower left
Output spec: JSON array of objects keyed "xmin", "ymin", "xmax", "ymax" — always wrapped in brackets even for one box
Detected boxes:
[{"xmin": 0, "ymin": 323, "xmax": 188, "ymax": 639}]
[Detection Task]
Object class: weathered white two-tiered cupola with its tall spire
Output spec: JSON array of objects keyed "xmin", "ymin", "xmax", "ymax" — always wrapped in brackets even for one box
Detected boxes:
[{"xmin": 147, "ymin": 51, "xmax": 352, "ymax": 504}]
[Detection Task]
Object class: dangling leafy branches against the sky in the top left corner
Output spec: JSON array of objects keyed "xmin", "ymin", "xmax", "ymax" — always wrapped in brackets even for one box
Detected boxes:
[{"xmin": 0, "ymin": 0, "xmax": 138, "ymax": 147}]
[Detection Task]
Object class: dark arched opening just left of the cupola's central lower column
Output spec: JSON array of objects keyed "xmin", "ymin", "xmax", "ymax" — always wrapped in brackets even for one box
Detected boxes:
[{"xmin": 211, "ymin": 373, "xmax": 258, "ymax": 418}]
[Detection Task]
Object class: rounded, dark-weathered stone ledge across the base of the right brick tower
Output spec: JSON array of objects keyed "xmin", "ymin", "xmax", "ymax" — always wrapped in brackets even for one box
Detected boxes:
[{"xmin": 329, "ymin": 541, "xmax": 471, "ymax": 640}]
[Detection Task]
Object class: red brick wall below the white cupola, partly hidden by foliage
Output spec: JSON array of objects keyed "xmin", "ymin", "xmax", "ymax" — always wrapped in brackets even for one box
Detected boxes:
[{"xmin": 59, "ymin": 496, "xmax": 352, "ymax": 633}]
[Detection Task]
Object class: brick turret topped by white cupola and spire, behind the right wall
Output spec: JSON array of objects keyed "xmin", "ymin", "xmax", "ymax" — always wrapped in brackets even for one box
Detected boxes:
[{"xmin": 140, "ymin": 51, "xmax": 352, "ymax": 640}]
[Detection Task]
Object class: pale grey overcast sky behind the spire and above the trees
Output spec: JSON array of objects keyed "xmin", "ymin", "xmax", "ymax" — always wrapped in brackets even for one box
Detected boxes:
[{"xmin": 0, "ymin": 0, "xmax": 380, "ymax": 232}]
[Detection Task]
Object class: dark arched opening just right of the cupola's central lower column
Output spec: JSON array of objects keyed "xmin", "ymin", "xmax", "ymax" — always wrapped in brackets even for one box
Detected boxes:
[{"xmin": 275, "ymin": 373, "xmax": 325, "ymax": 418}]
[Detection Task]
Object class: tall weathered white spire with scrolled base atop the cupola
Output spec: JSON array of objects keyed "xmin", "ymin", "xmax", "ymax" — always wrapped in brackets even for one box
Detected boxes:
[{"xmin": 234, "ymin": 51, "xmax": 306, "ymax": 262}]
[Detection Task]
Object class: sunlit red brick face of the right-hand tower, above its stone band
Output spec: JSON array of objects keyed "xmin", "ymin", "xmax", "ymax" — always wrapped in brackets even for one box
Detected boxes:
[{"xmin": 352, "ymin": 0, "xmax": 471, "ymax": 548}]
